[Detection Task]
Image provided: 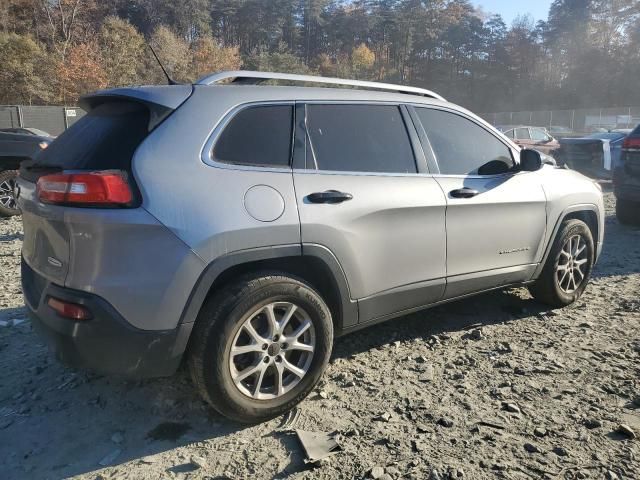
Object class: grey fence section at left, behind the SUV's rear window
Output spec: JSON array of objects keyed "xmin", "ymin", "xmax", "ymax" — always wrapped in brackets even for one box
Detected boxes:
[{"xmin": 0, "ymin": 105, "xmax": 86, "ymax": 136}]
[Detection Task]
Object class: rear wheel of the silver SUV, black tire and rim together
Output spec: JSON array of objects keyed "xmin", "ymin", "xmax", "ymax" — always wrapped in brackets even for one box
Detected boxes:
[{"xmin": 188, "ymin": 273, "xmax": 333, "ymax": 423}]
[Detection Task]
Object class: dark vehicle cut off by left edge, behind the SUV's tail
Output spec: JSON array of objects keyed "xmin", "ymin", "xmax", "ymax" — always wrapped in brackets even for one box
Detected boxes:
[{"xmin": 0, "ymin": 128, "xmax": 54, "ymax": 216}]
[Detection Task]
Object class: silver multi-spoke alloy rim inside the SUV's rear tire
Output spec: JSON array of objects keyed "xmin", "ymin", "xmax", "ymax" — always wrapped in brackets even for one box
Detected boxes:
[{"xmin": 228, "ymin": 302, "xmax": 315, "ymax": 400}]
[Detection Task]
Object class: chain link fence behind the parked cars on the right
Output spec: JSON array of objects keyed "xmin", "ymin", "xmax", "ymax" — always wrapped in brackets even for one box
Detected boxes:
[{"xmin": 481, "ymin": 107, "xmax": 640, "ymax": 133}]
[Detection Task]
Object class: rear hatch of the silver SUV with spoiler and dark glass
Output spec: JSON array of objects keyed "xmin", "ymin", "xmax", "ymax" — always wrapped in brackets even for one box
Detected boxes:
[{"xmin": 18, "ymin": 86, "xmax": 191, "ymax": 293}]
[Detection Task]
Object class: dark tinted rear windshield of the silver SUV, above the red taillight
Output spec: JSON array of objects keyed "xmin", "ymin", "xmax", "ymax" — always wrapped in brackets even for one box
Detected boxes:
[{"xmin": 35, "ymin": 101, "xmax": 149, "ymax": 170}]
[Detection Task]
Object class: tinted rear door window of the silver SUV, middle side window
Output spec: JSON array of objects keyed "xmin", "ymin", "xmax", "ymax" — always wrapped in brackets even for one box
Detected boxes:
[{"xmin": 307, "ymin": 104, "xmax": 417, "ymax": 173}]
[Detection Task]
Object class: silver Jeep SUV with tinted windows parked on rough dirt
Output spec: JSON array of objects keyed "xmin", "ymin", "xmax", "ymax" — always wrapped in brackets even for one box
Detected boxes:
[{"xmin": 17, "ymin": 72, "xmax": 604, "ymax": 422}]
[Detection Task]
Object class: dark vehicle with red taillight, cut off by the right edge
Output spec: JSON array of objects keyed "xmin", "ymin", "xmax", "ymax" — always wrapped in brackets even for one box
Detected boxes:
[{"xmin": 613, "ymin": 125, "xmax": 640, "ymax": 225}]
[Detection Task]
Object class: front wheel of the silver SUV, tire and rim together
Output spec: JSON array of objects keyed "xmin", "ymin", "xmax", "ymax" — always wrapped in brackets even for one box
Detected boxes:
[{"xmin": 529, "ymin": 220, "xmax": 595, "ymax": 307}]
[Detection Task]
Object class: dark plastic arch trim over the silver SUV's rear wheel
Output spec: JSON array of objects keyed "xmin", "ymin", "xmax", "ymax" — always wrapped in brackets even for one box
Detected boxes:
[{"xmin": 180, "ymin": 244, "xmax": 358, "ymax": 335}]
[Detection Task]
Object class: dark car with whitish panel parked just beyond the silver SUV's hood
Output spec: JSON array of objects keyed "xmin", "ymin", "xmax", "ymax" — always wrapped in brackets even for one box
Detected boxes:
[{"xmin": 556, "ymin": 132, "xmax": 627, "ymax": 179}]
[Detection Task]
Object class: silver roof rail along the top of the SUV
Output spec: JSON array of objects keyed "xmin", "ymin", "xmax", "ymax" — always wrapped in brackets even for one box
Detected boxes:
[{"xmin": 196, "ymin": 70, "xmax": 445, "ymax": 101}]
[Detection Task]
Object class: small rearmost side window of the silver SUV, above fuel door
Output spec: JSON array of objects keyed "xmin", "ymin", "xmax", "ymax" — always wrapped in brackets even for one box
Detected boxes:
[{"xmin": 213, "ymin": 105, "xmax": 293, "ymax": 167}]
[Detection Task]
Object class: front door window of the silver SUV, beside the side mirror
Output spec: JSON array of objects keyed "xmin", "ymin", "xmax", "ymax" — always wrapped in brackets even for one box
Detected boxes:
[{"xmin": 416, "ymin": 108, "xmax": 513, "ymax": 175}]
